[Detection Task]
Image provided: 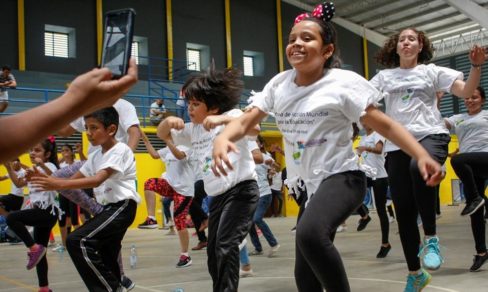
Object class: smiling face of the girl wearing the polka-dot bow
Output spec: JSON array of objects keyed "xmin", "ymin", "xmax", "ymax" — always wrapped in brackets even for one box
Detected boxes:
[{"xmin": 286, "ymin": 20, "xmax": 334, "ymax": 72}]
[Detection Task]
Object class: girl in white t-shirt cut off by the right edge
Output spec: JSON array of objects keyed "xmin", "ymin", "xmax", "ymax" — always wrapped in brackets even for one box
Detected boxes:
[{"xmin": 445, "ymin": 87, "xmax": 488, "ymax": 272}]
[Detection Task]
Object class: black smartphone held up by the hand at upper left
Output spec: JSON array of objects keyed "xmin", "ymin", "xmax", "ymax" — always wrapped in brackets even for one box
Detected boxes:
[{"xmin": 100, "ymin": 8, "xmax": 136, "ymax": 79}]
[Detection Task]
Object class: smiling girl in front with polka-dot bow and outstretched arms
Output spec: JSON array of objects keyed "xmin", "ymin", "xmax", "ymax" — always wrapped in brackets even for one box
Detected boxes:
[{"xmin": 213, "ymin": 3, "xmax": 441, "ymax": 292}]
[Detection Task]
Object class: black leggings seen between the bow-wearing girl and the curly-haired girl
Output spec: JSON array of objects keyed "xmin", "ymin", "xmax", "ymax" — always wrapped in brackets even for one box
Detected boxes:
[{"xmin": 368, "ymin": 177, "xmax": 390, "ymax": 244}]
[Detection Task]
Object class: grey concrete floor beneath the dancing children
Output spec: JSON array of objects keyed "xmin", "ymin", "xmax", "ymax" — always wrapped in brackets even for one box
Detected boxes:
[{"xmin": 0, "ymin": 206, "xmax": 488, "ymax": 292}]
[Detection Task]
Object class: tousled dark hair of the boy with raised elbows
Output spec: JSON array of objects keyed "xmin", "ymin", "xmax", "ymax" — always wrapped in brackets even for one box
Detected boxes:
[{"xmin": 183, "ymin": 66, "xmax": 244, "ymax": 115}]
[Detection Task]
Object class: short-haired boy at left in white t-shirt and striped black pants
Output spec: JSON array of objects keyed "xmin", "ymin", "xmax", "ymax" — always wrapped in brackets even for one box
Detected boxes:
[{"xmin": 33, "ymin": 107, "xmax": 140, "ymax": 291}]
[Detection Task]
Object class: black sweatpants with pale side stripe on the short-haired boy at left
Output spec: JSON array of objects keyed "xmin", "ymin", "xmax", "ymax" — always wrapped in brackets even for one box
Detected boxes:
[{"xmin": 66, "ymin": 200, "xmax": 137, "ymax": 292}]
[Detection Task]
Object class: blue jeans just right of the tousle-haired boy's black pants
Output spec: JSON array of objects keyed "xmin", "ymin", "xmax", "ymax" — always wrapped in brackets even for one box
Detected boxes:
[{"xmin": 249, "ymin": 194, "xmax": 278, "ymax": 251}]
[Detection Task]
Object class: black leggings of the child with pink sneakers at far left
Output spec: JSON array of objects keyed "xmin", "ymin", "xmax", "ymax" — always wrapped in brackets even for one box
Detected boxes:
[{"xmin": 7, "ymin": 207, "xmax": 58, "ymax": 287}]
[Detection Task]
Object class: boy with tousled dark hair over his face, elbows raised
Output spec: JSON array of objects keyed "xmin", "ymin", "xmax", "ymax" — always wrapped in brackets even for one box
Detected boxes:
[{"xmin": 157, "ymin": 68, "xmax": 259, "ymax": 291}]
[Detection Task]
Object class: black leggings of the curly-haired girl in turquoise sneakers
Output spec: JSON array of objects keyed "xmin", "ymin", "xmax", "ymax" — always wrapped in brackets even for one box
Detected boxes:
[{"xmin": 386, "ymin": 134, "xmax": 451, "ymax": 271}]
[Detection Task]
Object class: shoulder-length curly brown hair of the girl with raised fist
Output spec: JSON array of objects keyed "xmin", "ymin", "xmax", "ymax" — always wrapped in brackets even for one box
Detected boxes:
[{"xmin": 376, "ymin": 27, "xmax": 434, "ymax": 68}]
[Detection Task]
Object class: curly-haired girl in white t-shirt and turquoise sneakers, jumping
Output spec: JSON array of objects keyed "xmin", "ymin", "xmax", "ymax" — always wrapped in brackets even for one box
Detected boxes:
[{"xmin": 370, "ymin": 28, "xmax": 485, "ymax": 285}]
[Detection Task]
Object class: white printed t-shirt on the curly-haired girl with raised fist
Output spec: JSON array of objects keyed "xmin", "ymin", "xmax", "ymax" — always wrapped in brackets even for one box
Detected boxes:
[{"xmin": 370, "ymin": 64, "xmax": 463, "ymax": 152}]
